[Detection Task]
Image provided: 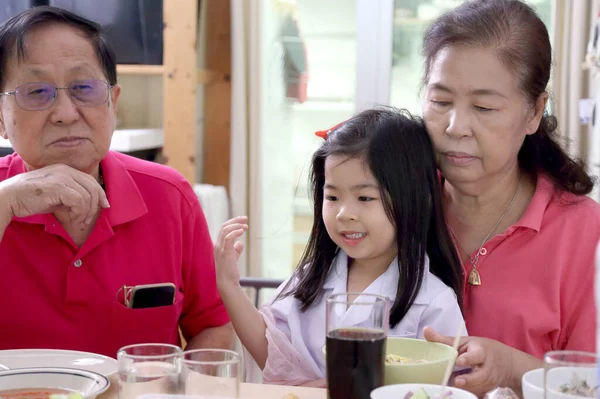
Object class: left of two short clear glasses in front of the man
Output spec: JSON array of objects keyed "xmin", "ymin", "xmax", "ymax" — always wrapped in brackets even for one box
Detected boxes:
[{"xmin": 117, "ymin": 344, "xmax": 183, "ymax": 399}]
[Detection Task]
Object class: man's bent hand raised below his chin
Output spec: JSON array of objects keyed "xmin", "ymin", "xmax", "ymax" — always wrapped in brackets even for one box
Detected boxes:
[{"xmin": 0, "ymin": 164, "xmax": 110, "ymax": 224}]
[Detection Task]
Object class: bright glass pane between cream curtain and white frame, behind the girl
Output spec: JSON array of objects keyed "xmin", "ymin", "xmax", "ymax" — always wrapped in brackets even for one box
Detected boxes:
[{"xmin": 250, "ymin": 0, "xmax": 356, "ymax": 278}]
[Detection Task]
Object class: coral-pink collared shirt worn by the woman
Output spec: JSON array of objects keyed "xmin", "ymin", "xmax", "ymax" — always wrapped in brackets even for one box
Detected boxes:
[{"xmin": 464, "ymin": 175, "xmax": 600, "ymax": 358}]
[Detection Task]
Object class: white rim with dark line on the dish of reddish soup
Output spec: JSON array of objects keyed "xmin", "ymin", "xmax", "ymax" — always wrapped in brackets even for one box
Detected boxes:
[{"xmin": 0, "ymin": 368, "xmax": 110, "ymax": 399}]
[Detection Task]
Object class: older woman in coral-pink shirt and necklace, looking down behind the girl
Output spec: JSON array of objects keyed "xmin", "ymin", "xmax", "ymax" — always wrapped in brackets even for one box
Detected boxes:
[{"xmin": 423, "ymin": 0, "xmax": 600, "ymax": 395}]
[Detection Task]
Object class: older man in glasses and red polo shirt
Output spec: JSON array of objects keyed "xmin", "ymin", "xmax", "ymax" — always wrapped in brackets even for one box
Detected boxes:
[{"xmin": 0, "ymin": 7, "xmax": 233, "ymax": 357}]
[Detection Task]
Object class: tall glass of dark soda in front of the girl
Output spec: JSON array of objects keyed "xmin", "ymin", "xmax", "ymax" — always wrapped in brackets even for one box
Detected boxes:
[{"xmin": 325, "ymin": 292, "xmax": 390, "ymax": 399}]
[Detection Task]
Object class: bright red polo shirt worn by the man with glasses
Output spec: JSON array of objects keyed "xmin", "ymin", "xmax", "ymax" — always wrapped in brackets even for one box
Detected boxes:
[{"xmin": 0, "ymin": 152, "xmax": 229, "ymax": 357}]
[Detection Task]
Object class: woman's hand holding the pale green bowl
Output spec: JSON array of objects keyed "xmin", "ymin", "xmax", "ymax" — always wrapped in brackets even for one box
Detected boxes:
[{"xmin": 424, "ymin": 327, "xmax": 542, "ymax": 397}]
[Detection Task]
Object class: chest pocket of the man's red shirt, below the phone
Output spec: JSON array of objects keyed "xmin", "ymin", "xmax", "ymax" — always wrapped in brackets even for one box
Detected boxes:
[{"xmin": 110, "ymin": 295, "xmax": 182, "ymax": 349}]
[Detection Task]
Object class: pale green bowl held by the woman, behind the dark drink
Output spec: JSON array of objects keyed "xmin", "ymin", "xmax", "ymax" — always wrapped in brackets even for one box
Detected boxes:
[{"xmin": 384, "ymin": 337, "xmax": 457, "ymax": 385}]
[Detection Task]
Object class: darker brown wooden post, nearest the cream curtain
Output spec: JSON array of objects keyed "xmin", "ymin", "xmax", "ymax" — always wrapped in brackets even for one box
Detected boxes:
[{"xmin": 202, "ymin": 0, "xmax": 231, "ymax": 192}]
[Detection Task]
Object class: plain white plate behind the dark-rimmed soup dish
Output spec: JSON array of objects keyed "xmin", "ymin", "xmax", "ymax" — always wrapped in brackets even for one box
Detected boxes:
[{"xmin": 0, "ymin": 349, "xmax": 119, "ymax": 377}]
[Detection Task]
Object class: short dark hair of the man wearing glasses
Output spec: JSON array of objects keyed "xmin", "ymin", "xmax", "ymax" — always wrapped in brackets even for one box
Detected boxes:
[{"xmin": 0, "ymin": 6, "xmax": 117, "ymax": 87}]
